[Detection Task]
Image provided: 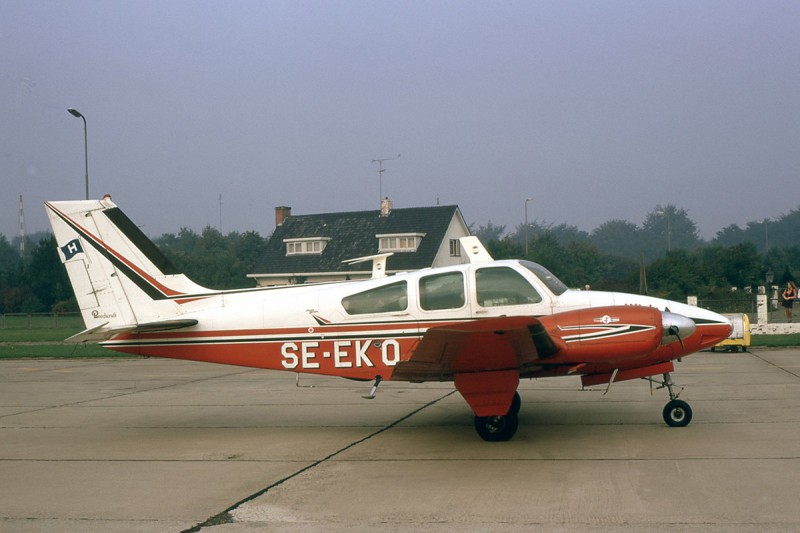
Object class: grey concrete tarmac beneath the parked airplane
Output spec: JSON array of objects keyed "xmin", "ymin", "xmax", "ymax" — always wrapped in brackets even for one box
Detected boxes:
[{"xmin": 0, "ymin": 349, "xmax": 800, "ymax": 533}]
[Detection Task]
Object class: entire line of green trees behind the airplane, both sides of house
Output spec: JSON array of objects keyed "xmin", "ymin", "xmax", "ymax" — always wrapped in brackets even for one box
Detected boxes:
[{"xmin": 0, "ymin": 205, "xmax": 800, "ymax": 313}]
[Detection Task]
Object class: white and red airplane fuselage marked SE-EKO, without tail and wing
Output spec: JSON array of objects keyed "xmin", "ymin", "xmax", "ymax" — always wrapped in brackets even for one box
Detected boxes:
[{"xmin": 104, "ymin": 260, "xmax": 729, "ymax": 380}]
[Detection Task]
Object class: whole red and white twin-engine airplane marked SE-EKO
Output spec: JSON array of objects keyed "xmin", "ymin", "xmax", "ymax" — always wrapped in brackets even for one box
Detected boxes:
[{"xmin": 45, "ymin": 195, "xmax": 732, "ymax": 441}]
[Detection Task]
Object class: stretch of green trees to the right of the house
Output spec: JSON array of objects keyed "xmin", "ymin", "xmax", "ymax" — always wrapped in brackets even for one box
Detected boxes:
[{"xmin": 474, "ymin": 205, "xmax": 800, "ymax": 300}]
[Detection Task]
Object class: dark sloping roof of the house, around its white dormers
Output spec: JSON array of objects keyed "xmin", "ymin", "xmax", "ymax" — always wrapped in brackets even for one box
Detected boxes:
[{"xmin": 253, "ymin": 205, "xmax": 460, "ymax": 274}]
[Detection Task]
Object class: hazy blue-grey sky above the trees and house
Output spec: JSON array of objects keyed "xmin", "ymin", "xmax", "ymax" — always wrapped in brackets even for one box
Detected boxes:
[{"xmin": 0, "ymin": 0, "xmax": 800, "ymax": 238}]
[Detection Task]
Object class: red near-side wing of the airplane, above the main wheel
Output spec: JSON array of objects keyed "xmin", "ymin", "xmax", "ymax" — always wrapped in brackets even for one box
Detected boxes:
[{"xmin": 392, "ymin": 316, "xmax": 563, "ymax": 382}]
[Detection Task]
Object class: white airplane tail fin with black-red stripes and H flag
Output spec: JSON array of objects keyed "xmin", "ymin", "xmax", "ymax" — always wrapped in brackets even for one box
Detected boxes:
[{"xmin": 45, "ymin": 196, "xmax": 213, "ymax": 342}]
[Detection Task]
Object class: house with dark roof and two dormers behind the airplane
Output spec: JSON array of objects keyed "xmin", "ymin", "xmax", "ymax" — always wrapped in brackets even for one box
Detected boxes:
[{"xmin": 247, "ymin": 198, "xmax": 469, "ymax": 286}]
